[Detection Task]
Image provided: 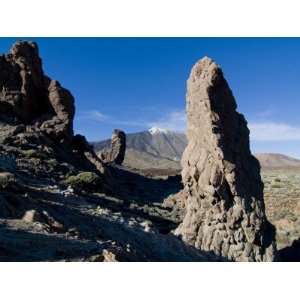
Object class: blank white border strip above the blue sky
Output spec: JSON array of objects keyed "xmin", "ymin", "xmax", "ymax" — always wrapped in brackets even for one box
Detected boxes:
[{"xmin": 0, "ymin": 0, "xmax": 300, "ymax": 37}]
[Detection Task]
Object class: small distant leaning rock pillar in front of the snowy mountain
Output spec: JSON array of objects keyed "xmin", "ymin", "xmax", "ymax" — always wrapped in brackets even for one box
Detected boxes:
[{"xmin": 99, "ymin": 129, "xmax": 126, "ymax": 165}]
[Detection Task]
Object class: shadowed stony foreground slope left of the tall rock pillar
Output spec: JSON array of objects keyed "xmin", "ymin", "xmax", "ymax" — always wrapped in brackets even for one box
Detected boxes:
[{"xmin": 0, "ymin": 161, "xmax": 220, "ymax": 261}]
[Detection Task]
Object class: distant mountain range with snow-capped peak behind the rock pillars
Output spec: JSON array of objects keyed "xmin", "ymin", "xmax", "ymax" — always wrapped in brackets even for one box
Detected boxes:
[{"xmin": 92, "ymin": 127, "xmax": 300, "ymax": 169}]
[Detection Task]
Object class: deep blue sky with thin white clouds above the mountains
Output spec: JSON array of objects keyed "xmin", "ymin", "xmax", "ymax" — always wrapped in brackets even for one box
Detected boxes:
[{"xmin": 0, "ymin": 38, "xmax": 300, "ymax": 158}]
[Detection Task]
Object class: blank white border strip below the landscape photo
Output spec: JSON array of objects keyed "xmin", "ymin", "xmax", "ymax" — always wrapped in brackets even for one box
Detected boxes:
[{"xmin": 0, "ymin": 263, "xmax": 299, "ymax": 300}]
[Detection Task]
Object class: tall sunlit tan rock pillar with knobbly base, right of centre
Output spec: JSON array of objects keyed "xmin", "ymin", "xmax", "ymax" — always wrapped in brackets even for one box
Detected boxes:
[{"xmin": 175, "ymin": 57, "xmax": 276, "ymax": 261}]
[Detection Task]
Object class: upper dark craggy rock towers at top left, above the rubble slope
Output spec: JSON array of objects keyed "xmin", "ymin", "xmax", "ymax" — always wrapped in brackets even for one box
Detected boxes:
[{"xmin": 0, "ymin": 42, "xmax": 75, "ymax": 140}]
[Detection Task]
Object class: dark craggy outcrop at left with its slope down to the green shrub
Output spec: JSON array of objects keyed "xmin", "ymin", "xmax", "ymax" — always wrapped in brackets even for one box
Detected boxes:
[{"xmin": 0, "ymin": 41, "xmax": 105, "ymax": 177}]
